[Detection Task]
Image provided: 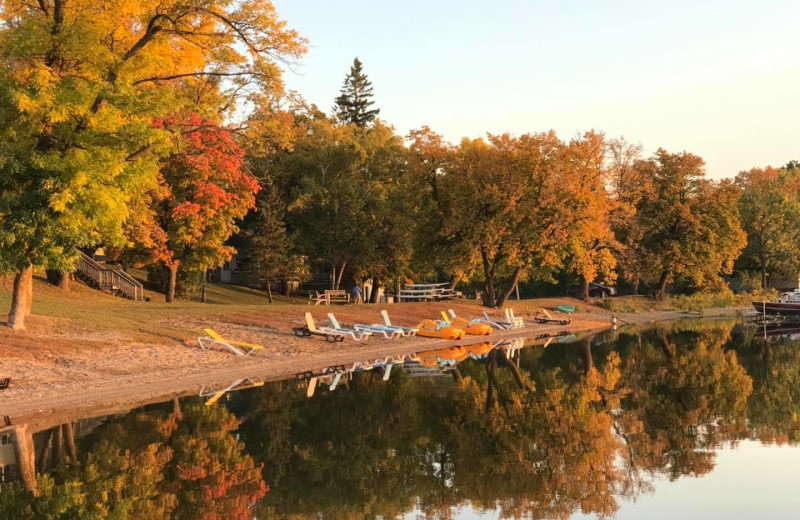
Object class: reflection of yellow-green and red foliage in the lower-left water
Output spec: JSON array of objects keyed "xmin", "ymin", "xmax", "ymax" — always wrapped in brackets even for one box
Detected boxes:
[{"xmin": 0, "ymin": 403, "xmax": 267, "ymax": 520}]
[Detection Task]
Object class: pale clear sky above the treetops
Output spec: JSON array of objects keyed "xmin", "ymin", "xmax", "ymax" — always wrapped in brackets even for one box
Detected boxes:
[{"xmin": 273, "ymin": 0, "xmax": 800, "ymax": 178}]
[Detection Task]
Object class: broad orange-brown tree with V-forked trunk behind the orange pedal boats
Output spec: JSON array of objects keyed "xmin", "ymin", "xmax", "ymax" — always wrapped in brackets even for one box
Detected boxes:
[{"xmin": 442, "ymin": 132, "xmax": 568, "ymax": 307}]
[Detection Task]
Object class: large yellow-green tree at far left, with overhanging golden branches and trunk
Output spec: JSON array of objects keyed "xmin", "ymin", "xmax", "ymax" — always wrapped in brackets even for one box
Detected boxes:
[{"xmin": 0, "ymin": 0, "xmax": 305, "ymax": 328}]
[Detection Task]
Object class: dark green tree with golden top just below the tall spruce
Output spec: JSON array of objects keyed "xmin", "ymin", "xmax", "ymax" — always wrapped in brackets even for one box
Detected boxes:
[{"xmin": 273, "ymin": 114, "xmax": 410, "ymax": 288}]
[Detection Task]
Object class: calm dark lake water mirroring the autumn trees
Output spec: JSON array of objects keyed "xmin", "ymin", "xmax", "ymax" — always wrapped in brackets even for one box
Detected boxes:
[{"xmin": 0, "ymin": 321, "xmax": 800, "ymax": 520}]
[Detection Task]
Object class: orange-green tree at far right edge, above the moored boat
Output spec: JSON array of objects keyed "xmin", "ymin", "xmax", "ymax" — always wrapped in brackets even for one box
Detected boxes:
[{"xmin": 736, "ymin": 167, "xmax": 800, "ymax": 288}]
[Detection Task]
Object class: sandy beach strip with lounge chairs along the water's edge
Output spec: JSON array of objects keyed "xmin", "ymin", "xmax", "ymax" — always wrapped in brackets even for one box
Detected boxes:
[{"xmin": 0, "ymin": 290, "xmax": 756, "ymax": 424}]
